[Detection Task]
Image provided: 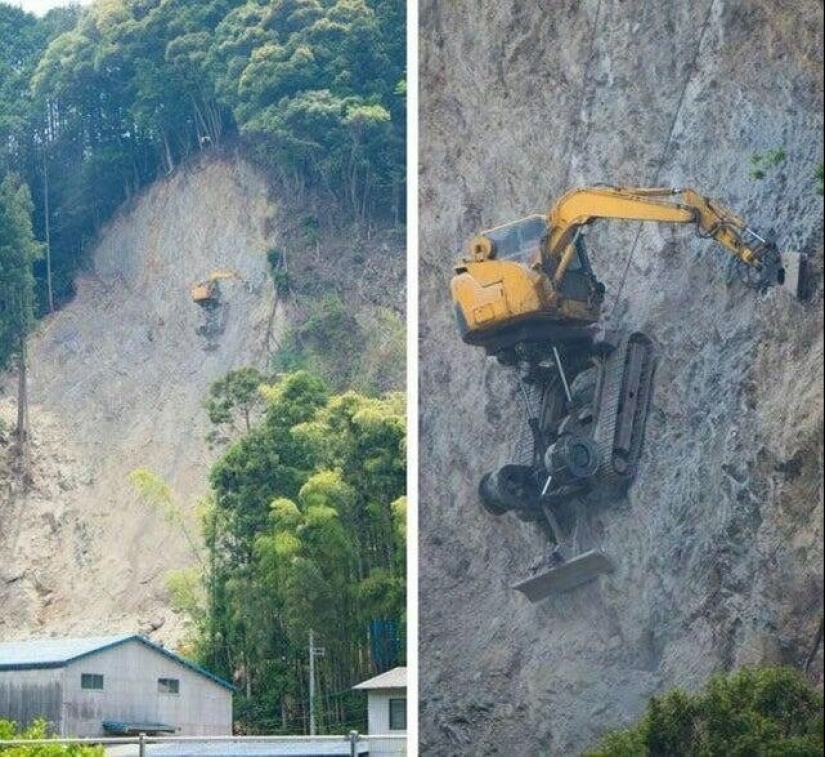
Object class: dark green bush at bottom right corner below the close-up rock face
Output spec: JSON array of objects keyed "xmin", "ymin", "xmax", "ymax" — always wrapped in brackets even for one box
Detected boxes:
[{"xmin": 587, "ymin": 668, "xmax": 825, "ymax": 757}]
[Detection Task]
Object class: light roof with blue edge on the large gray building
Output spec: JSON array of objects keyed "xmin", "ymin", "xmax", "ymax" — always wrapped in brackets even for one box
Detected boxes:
[{"xmin": 0, "ymin": 634, "xmax": 235, "ymax": 689}]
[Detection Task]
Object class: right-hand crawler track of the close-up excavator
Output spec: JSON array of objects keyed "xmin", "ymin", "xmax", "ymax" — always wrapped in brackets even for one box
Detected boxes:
[{"xmin": 593, "ymin": 331, "xmax": 655, "ymax": 492}]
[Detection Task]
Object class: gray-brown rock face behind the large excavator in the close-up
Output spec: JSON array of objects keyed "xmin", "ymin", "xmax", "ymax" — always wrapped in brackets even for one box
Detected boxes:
[{"xmin": 419, "ymin": 0, "xmax": 823, "ymax": 755}]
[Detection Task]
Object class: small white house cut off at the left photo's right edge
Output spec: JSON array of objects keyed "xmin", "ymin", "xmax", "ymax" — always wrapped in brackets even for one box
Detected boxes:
[{"xmin": 353, "ymin": 668, "xmax": 407, "ymax": 755}]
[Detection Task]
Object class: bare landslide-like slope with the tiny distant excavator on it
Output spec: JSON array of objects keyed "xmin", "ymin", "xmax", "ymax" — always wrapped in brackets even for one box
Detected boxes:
[{"xmin": 0, "ymin": 155, "xmax": 403, "ymax": 643}]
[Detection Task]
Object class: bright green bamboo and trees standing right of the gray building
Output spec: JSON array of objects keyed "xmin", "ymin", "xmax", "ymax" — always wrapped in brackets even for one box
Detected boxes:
[{"xmin": 193, "ymin": 372, "xmax": 406, "ymax": 732}]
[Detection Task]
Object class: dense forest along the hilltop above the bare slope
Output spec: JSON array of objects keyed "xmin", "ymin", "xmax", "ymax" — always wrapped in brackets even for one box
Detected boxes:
[{"xmin": 0, "ymin": 0, "xmax": 405, "ymax": 312}]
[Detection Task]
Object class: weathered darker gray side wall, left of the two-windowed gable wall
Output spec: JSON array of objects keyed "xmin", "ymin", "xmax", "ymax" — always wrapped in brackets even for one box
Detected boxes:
[{"xmin": 0, "ymin": 668, "xmax": 63, "ymax": 731}]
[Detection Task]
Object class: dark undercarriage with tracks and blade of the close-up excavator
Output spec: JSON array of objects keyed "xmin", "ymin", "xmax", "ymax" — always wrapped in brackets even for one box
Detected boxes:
[{"xmin": 479, "ymin": 332, "xmax": 655, "ymax": 601}]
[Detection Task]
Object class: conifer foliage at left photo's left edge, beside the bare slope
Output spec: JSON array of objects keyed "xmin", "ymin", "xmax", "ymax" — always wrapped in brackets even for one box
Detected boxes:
[{"xmin": 0, "ymin": 174, "xmax": 40, "ymax": 369}]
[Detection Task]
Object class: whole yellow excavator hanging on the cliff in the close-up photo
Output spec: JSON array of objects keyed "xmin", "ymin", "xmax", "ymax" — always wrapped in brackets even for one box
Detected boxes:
[{"xmin": 451, "ymin": 186, "xmax": 806, "ymax": 601}]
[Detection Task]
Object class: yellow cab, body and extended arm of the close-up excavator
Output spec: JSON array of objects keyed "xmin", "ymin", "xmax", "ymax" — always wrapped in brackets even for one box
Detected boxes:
[{"xmin": 450, "ymin": 186, "xmax": 804, "ymax": 351}]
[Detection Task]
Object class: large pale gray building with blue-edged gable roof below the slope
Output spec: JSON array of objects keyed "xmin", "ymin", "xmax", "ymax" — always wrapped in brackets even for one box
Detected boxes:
[{"xmin": 0, "ymin": 635, "xmax": 234, "ymax": 737}]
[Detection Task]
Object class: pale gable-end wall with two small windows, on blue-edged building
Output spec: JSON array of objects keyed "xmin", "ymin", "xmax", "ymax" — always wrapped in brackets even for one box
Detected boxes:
[{"xmin": 63, "ymin": 641, "xmax": 232, "ymax": 736}]
